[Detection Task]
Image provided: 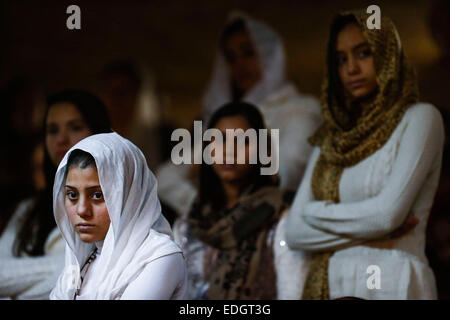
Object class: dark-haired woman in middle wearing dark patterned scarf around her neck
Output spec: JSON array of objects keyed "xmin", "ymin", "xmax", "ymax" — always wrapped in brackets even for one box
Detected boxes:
[{"xmin": 174, "ymin": 102, "xmax": 288, "ymax": 300}]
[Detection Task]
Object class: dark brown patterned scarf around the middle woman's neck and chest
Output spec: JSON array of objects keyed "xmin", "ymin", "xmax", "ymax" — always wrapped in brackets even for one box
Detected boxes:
[{"xmin": 189, "ymin": 186, "xmax": 287, "ymax": 300}]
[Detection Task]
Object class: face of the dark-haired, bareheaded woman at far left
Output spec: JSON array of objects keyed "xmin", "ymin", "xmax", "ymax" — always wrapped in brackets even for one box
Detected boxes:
[{"xmin": 45, "ymin": 102, "xmax": 93, "ymax": 166}]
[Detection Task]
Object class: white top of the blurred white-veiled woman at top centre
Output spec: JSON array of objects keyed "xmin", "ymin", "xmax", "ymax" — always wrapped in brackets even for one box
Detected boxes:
[{"xmin": 156, "ymin": 83, "xmax": 322, "ymax": 215}]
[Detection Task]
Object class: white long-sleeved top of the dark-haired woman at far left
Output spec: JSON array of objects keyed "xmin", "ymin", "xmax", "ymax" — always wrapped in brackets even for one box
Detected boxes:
[{"xmin": 0, "ymin": 199, "xmax": 65, "ymax": 300}]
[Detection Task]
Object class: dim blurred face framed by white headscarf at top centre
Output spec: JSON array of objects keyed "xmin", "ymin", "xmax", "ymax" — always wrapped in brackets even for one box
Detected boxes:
[{"xmin": 224, "ymin": 31, "xmax": 262, "ymax": 94}]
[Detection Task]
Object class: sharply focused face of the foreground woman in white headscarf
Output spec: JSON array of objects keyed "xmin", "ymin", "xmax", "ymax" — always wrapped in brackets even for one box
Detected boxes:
[{"xmin": 64, "ymin": 166, "xmax": 111, "ymax": 242}]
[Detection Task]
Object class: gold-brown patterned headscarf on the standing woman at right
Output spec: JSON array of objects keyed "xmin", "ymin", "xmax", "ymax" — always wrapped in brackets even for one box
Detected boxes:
[{"xmin": 302, "ymin": 11, "xmax": 419, "ymax": 299}]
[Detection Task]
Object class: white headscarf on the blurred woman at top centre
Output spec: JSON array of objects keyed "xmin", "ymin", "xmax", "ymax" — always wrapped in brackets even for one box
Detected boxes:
[{"xmin": 203, "ymin": 12, "xmax": 286, "ymax": 120}]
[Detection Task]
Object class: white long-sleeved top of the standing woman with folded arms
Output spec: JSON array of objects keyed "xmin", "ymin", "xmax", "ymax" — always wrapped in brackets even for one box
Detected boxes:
[{"xmin": 278, "ymin": 103, "xmax": 444, "ymax": 299}]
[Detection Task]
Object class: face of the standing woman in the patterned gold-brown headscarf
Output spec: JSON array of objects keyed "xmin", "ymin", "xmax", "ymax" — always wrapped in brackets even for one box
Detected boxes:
[{"xmin": 336, "ymin": 23, "xmax": 377, "ymax": 98}]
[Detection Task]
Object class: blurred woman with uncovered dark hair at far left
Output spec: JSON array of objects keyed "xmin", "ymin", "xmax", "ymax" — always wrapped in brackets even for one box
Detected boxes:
[{"xmin": 0, "ymin": 90, "xmax": 111, "ymax": 299}]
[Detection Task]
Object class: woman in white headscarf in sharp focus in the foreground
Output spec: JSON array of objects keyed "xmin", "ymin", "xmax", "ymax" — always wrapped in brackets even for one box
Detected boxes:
[{"xmin": 50, "ymin": 133, "xmax": 186, "ymax": 300}]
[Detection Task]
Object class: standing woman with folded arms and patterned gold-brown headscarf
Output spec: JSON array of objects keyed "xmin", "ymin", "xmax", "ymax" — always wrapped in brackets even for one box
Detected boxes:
[{"xmin": 278, "ymin": 11, "xmax": 444, "ymax": 299}]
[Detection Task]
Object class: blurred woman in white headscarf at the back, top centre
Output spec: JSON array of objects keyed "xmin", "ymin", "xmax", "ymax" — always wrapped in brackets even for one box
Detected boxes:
[{"xmin": 157, "ymin": 13, "xmax": 321, "ymax": 218}]
